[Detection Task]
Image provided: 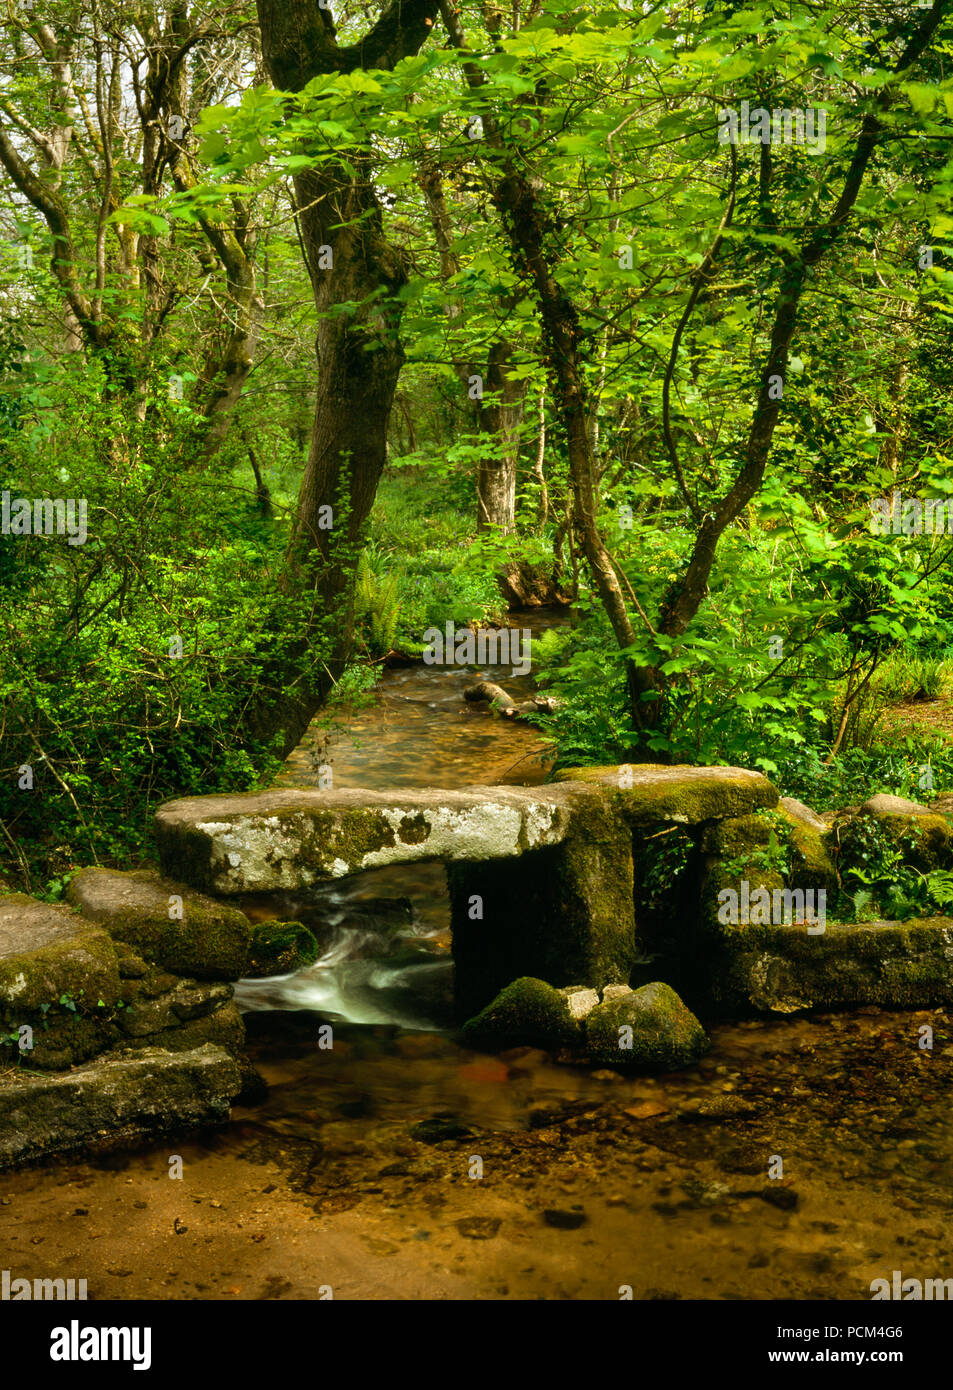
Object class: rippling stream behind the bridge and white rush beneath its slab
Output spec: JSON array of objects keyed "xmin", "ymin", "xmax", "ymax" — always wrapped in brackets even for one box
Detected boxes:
[{"xmin": 235, "ymin": 610, "xmax": 555, "ymax": 1029}]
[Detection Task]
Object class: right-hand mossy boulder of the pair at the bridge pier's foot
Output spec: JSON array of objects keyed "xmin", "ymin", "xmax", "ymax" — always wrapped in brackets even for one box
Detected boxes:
[{"xmin": 586, "ymin": 981, "xmax": 708, "ymax": 1072}]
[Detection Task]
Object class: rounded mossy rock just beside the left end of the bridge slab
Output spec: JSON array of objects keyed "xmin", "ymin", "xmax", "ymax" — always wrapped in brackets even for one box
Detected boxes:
[{"xmin": 67, "ymin": 869, "xmax": 251, "ymax": 980}]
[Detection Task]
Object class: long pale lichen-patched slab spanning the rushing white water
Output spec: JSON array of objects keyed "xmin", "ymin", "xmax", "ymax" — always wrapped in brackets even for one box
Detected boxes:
[{"xmin": 156, "ymin": 787, "xmax": 588, "ymax": 895}]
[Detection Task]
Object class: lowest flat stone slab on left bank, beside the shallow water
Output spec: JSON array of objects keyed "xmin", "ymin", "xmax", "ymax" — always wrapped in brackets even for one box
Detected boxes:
[{"xmin": 0, "ymin": 1043, "xmax": 242, "ymax": 1168}]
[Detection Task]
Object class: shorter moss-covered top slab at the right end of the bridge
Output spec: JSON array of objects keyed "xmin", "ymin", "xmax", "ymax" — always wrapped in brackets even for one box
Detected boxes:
[{"xmin": 553, "ymin": 763, "xmax": 778, "ymax": 830}]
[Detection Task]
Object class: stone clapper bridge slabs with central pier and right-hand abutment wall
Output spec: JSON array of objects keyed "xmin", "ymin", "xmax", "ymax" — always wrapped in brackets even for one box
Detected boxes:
[{"xmin": 156, "ymin": 765, "xmax": 953, "ymax": 1017}]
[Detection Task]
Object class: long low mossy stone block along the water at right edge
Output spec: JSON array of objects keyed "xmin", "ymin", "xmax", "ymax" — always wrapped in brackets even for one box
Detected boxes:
[{"xmin": 710, "ymin": 917, "xmax": 953, "ymax": 1015}]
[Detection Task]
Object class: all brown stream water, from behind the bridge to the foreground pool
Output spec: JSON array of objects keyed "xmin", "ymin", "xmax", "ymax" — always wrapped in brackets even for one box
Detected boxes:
[{"xmin": 0, "ymin": 614, "xmax": 953, "ymax": 1300}]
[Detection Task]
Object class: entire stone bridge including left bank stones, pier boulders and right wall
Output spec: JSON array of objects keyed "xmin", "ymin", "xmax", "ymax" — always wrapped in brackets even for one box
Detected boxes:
[{"xmin": 0, "ymin": 766, "xmax": 953, "ymax": 1168}]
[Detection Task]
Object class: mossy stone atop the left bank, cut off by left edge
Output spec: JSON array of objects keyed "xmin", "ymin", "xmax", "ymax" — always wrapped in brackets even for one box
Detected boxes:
[{"xmin": 0, "ymin": 892, "xmax": 119, "ymax": 1019}]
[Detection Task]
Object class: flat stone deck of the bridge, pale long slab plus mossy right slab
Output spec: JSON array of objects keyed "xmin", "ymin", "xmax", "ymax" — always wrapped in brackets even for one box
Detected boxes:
[{"xmin": 156, "ymin": 765, "xmax": 778, "ymax": 895}]
